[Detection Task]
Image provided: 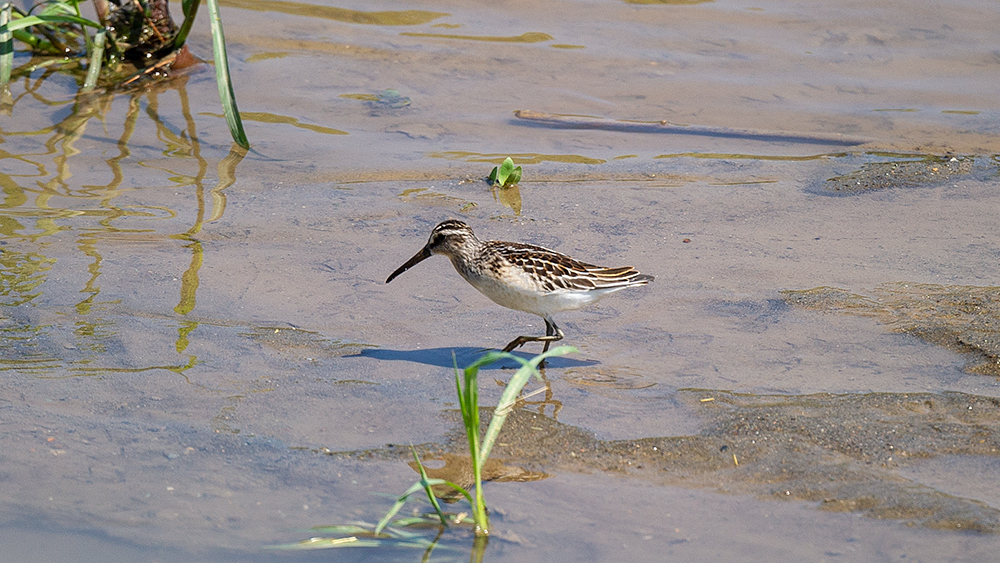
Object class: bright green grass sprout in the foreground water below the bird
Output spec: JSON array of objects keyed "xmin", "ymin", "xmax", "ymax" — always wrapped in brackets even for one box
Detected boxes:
[{"xmin": 275, "ymin": 348, "xmax": 576, "ymax": 560}]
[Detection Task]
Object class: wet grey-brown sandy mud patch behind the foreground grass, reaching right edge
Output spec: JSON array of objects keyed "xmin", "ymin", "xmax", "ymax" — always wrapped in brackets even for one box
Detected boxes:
[{"xmin": 326, "ymin": 390, "xmax": 1000, "ymax": 534}]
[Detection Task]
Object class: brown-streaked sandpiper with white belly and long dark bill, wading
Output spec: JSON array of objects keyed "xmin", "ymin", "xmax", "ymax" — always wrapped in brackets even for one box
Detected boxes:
[{"xmin": 385, "ymin": 219, "xmax": 653, "ymax": 353}]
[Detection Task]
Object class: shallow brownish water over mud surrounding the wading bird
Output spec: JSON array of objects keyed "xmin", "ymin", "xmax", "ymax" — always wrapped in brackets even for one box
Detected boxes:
[{"xmin": 0, "ymin": 0, "xmax": 1000, "ymax": 561}]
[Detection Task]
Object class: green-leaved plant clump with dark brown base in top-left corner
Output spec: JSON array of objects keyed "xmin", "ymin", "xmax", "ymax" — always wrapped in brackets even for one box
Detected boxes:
[{"xmin": 0, "ymin": 0, "xmax": 249, "ymax": 148}]
